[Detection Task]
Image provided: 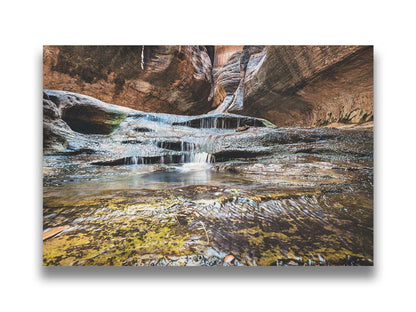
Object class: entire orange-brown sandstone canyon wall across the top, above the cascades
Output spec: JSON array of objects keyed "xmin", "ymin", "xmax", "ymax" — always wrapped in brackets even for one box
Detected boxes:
[{"xmin": 43, "ymin": 46, "xmax": 373, "ymax": 126}]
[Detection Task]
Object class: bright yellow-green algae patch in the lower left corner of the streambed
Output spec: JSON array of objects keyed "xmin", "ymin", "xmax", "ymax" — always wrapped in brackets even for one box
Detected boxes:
[{"xmin": 43, "ymin": 222, "xmax": 195, "ymax": 265}]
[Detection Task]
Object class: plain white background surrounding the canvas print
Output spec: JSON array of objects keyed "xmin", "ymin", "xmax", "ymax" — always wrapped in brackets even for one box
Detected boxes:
[{"xmin": 0, "ymin": 0, "xmax": 416, "ymax": 312}]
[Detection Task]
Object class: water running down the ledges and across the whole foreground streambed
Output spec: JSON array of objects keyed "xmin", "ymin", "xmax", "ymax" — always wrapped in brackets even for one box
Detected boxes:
[{"xmin": 44, "ymin": 114, "xmax": 373, "ymax": 265}]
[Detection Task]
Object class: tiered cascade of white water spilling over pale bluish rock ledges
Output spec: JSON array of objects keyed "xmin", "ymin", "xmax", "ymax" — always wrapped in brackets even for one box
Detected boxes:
[{"xmin": 106, "ymin": 113, "xmax": 265, "ymax": 168}]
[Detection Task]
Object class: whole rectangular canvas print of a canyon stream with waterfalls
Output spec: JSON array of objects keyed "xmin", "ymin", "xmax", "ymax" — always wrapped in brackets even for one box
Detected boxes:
[{"xmin": 43, "ymin": 45, "xmax": 374, "ymax": 266}]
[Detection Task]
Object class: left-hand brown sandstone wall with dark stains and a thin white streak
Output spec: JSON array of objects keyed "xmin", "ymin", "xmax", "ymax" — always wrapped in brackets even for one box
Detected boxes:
[{"xmin": 43, "ymin": 46, "xmax": 213, "ymax": 114}]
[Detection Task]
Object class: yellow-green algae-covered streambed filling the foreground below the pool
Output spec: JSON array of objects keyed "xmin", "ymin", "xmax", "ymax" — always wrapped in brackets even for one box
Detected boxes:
[{"xmin": 43, "ymin": 156, "xmax": 373, "ymax": 265}]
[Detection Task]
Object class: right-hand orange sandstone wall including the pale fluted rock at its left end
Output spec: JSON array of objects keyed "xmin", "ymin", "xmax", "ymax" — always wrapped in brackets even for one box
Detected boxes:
[{"xmin": 213, "ymin": 46, "xmax": 373, "ymax": 126}]
